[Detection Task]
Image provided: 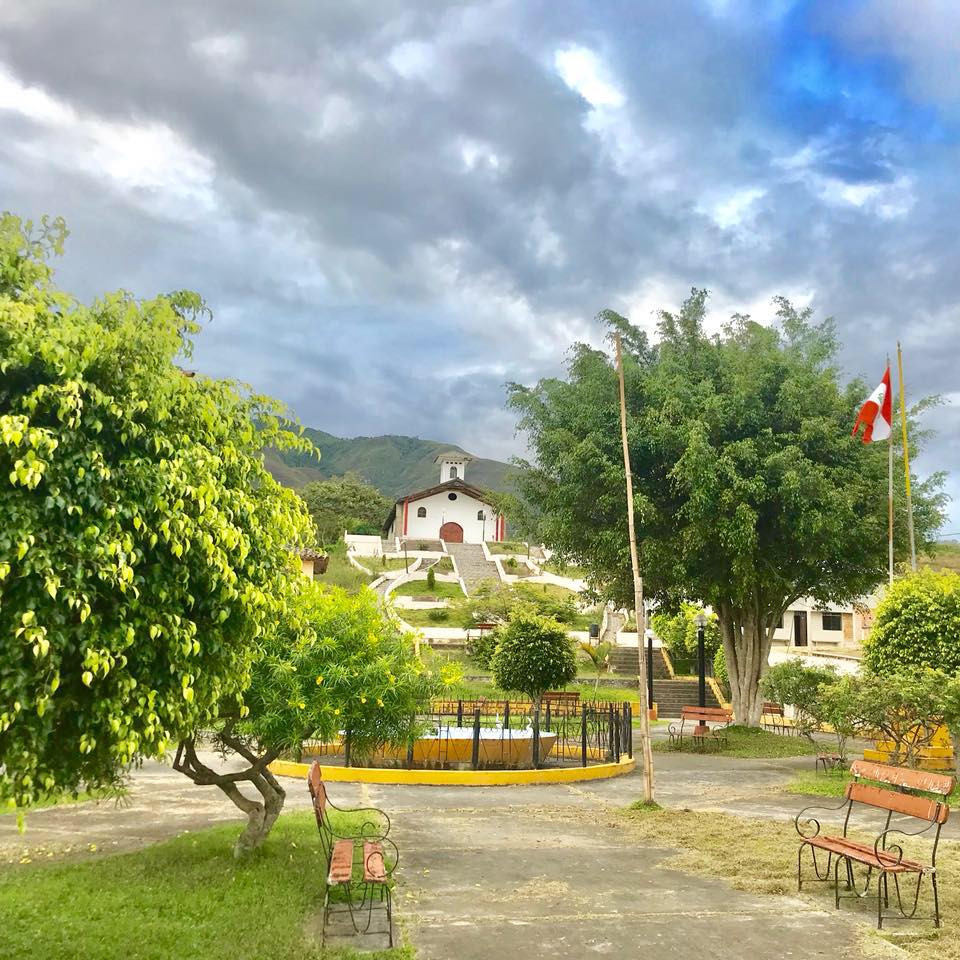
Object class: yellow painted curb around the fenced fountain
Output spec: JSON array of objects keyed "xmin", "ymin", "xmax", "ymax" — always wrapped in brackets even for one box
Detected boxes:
[{"xmin": 268, "ymin": 757, "xmax": 637, "ymax": 787}]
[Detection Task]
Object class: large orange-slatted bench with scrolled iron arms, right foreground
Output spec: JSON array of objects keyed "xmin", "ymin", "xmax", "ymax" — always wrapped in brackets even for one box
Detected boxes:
[{"xmin": 794, "ymin": 760, "xmax": 956, "ymax": 929}]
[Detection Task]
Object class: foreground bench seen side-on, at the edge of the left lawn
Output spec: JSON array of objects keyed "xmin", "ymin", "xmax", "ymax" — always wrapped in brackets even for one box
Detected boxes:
[{"xmin": 307, "ymin": 760, "xmax": 400, "ymax": 947}]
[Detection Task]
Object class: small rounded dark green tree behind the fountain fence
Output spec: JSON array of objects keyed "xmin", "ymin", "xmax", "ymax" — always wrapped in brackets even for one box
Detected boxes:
[{"xmin": 490, "ymin": 607, "xmax": 577, "ymax": 704}]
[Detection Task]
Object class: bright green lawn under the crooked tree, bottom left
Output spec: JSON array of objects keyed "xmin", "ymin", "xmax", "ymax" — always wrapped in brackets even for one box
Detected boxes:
[{"xmin": 0, "ymin": 812, "xmax": 413, "ymax": 960}]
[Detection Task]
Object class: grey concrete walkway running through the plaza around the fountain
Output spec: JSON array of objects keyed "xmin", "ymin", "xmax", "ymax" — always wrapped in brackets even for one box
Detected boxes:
[{"xmin": 0, "ymin": 754, "xmax": 908, "ymax": 960}]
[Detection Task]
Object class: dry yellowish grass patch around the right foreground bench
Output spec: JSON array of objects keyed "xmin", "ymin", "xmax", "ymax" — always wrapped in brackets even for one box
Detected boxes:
[{"xmin": 618, "ymin": 804, "xmax": 960, "ymax": 960}]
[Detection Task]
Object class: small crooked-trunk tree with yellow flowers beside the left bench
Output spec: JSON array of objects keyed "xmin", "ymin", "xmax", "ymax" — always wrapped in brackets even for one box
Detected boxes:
[{"xmin": 175, "ymin": 580, "xmax": 459, "ymax": 854}]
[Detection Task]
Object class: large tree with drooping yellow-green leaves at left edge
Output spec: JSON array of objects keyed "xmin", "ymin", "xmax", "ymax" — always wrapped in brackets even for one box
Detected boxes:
[{"xmin": 0, "ymin": 215, "xmax": 311, "ymax": 805}]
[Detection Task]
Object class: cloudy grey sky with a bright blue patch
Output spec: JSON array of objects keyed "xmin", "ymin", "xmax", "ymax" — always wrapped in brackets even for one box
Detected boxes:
[{"xmin": 0, "ymin": 0, "xmax": 960, "ymax": 533}]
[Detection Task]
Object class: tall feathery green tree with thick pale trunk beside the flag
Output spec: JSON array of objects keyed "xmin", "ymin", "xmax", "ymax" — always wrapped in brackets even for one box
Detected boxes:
[{"xmin": 510, "ymin": 290, "xmax": 942, "ymax": 724}]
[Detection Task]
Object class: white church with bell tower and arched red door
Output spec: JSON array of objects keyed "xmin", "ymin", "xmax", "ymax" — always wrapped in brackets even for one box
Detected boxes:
[{"xmin": 384, "ymin": 450, "xmax": 507, "ymax": 543}]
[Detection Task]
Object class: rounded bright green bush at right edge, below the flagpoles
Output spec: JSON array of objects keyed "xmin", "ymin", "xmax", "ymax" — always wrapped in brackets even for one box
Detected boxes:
[{"xmin": 863, "ymin": 570, "xmax": 960, "ymax": 676}]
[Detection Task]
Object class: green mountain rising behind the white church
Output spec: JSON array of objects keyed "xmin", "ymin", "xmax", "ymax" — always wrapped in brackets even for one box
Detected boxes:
[{"xmin": 266, "ymin": 427, "xmax": 519, "ymax": 497}]
